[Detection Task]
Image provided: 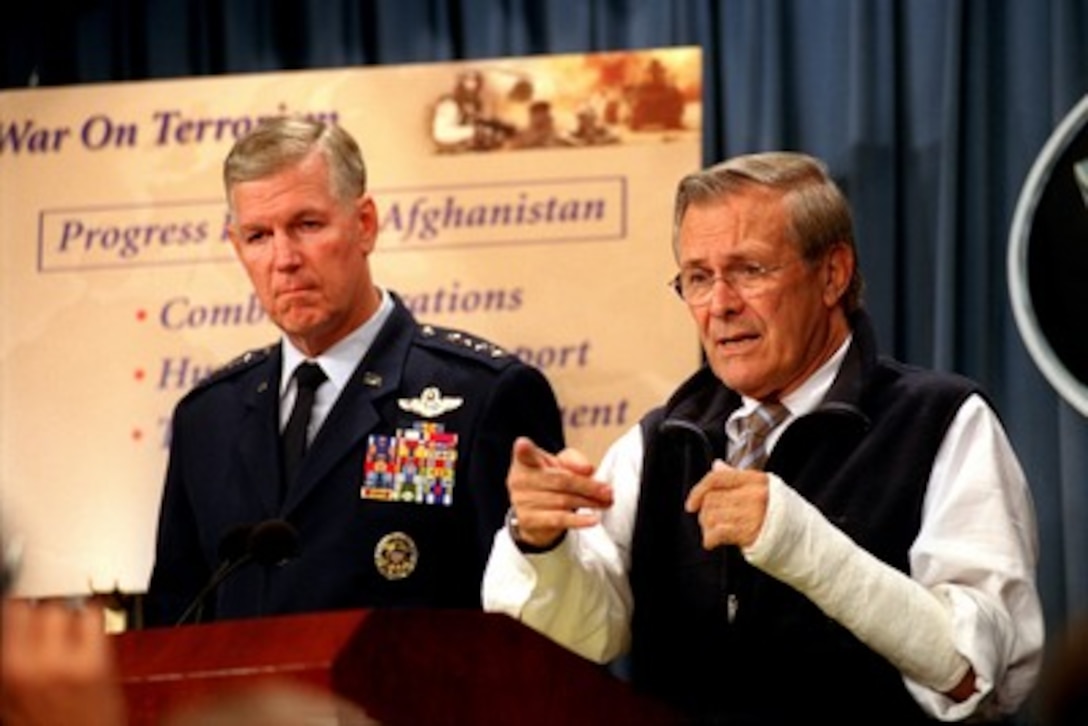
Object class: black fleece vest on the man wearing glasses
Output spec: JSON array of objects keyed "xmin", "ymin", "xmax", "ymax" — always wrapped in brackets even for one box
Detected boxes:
[{"xmin": 631, "ymin": 321, "xmax": 979, "ymax": 726}]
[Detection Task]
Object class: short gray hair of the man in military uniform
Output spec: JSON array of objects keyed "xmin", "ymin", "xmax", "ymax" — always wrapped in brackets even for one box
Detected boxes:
[{"xmin": 223, "ymin": 116, "xmax": 367, "ymax": 213}]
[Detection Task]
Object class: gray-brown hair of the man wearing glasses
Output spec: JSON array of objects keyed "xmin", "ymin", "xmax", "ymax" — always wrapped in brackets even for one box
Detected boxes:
[{"xmin": 672, "ymin": 151, "xmax": 864, "ymax": 313}]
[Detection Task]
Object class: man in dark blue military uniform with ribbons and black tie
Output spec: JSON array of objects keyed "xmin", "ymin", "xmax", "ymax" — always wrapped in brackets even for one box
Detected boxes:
[{"xmin": 145, "ymin": 118, "xmax": 562, "ymax": 625}]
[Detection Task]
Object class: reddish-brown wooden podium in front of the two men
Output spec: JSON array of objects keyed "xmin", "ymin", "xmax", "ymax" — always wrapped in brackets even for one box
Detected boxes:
[{"xmin": 113, "ymin": 610, "xmax": 680, "ymax": 726}]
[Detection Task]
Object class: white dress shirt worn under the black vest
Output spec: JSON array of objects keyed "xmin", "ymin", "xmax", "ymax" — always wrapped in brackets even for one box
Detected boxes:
[{"xmin": 483, "ymin": 341, "xmax": 1043, "ymax": 719}]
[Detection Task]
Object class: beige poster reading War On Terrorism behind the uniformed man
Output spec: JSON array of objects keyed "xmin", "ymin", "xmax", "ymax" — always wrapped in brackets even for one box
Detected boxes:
[{"xmin": 0, "ymin": 48, "xmax": 702, "ymax": 596}]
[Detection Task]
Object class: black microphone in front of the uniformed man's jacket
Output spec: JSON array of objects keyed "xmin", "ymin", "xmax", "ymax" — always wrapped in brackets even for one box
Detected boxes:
[{"xmin": 174, "ymin": 519, "xmax": 299, "ymax": 627}]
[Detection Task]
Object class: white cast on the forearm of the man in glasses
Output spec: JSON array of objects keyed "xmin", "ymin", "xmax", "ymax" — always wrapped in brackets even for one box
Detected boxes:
[{"xmin": 744, "ymin": 475, "xmax": 969, "ymax": 692}]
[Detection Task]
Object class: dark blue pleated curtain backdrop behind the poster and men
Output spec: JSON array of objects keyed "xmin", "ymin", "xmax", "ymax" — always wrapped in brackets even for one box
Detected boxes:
[{"xmin": 0, "ymin": 0, "xmax": 1088, "ymax": 714}]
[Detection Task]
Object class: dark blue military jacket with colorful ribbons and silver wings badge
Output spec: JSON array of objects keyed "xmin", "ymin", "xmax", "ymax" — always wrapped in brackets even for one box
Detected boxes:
[{"xmin": 145, "ymin": 298, "xmax": 562, "ymax": 625}]
